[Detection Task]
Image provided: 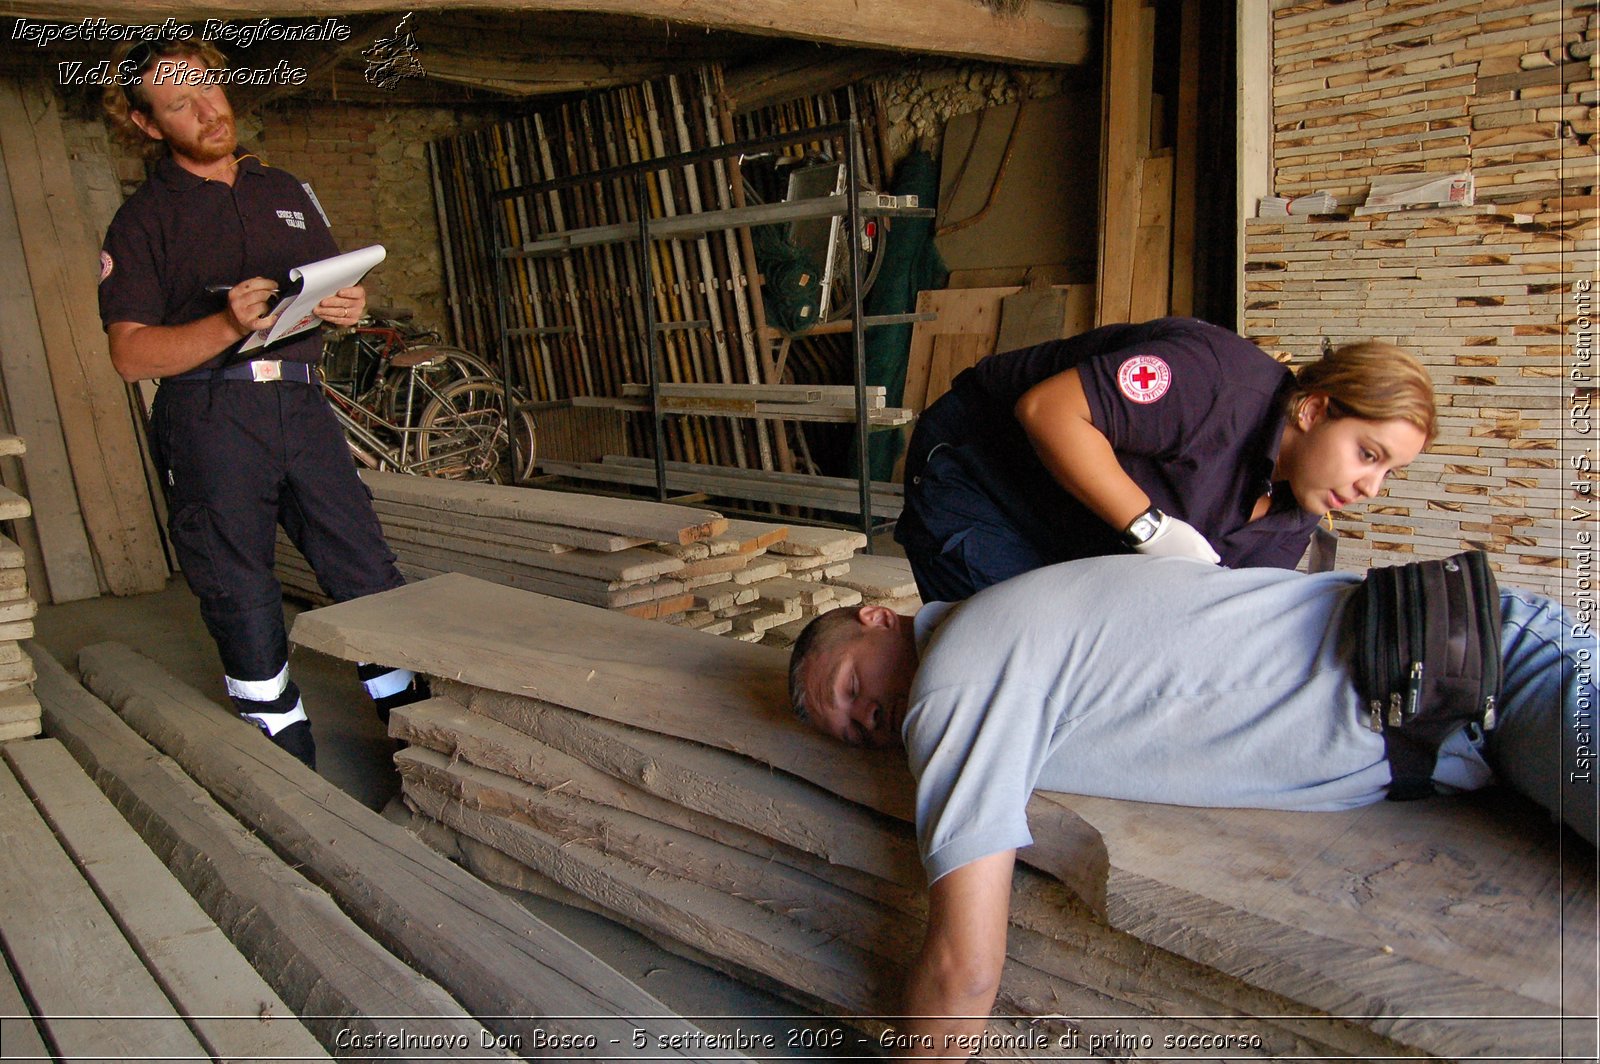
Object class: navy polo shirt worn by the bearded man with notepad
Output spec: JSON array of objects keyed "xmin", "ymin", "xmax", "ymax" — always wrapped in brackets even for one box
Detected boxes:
[{"xmin": 99, "ymin": 155, "xmax": 339, "ymax": 368}]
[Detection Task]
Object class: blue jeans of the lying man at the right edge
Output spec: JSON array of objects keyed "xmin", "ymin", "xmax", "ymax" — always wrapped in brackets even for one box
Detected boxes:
[{"xmin": 1483, "ymin": 589, "xmax": 1600, "ymax": 845}]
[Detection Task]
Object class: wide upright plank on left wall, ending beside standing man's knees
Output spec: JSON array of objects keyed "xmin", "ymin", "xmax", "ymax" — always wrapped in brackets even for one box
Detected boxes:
[{"xmin": 0, "ymin": 78, "xmax": 168, "ymax": 595}]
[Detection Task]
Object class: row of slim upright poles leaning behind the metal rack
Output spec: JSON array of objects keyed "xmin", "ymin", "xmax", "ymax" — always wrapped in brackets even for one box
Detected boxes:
[{"xmin": 429, "ymin": 66, "xmax": 883, "ymax": 469}]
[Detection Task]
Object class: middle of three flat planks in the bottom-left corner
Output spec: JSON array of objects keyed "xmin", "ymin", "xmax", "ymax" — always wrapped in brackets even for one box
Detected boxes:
[{"xmin": 0, "ymin": 766, "xmax": 205, "ymax": 1059}]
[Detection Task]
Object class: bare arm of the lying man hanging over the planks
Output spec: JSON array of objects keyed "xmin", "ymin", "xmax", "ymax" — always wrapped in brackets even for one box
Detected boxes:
[{"xmin": 893, "ymin": 850, "xmax": 1016, "ymax": 1059}]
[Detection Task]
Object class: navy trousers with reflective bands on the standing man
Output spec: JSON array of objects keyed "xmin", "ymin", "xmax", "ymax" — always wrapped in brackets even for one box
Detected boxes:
[{"xmin": 150, "ymin": 379, "xmax": 411, "ymax": 736}]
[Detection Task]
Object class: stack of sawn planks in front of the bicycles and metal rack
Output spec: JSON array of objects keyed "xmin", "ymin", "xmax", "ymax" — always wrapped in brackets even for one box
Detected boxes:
[{"xmin": 277, "ymin": 470, "xmax": 920, "ymax": 645}]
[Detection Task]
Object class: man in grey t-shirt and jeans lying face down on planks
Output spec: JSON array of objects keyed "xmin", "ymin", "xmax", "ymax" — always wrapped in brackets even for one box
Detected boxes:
[{"xmin": 789, "ymin": 557, "xmax": 1597, "ymax": 1053}]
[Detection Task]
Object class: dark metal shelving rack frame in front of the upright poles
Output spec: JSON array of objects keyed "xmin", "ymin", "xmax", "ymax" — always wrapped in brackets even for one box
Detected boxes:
[{"xmin": 483, "ymin": 99, "xmax": 933, "ymax": 542}]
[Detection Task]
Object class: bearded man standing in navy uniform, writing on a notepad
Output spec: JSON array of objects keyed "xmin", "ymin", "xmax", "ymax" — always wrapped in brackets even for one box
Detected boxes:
[{"xmin": 99, "ymin": 42, "xmax": 426, "ymax": 766}]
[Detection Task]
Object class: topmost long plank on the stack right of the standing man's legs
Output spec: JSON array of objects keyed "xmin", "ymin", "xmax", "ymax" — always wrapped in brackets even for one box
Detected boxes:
[{"xmin": 362, "ymin": 469, "xmax": 728, "ymax": 542}]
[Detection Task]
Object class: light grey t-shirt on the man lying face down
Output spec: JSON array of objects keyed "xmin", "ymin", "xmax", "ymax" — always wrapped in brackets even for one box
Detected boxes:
[{"xmin": 904, "ymin": 555, "xmax": 1491, "ymax": 880}]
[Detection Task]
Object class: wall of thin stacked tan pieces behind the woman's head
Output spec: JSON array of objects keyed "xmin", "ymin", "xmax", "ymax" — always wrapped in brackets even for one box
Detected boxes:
[{"xmin": 1245, "ymin": 0, "xmax": 1600, "ymax": 603}]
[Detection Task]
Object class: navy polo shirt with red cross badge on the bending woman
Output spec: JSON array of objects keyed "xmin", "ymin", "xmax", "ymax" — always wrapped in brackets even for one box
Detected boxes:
[{"xmin": 952, "ymin": 318, "xmax": 1317, "ymax": 568}]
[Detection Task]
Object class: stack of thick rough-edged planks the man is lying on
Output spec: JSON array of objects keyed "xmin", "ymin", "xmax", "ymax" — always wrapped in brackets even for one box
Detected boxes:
[{"xmin": 293, "ymin": 576, "xmax": 1595, "ymax": 1059}]
